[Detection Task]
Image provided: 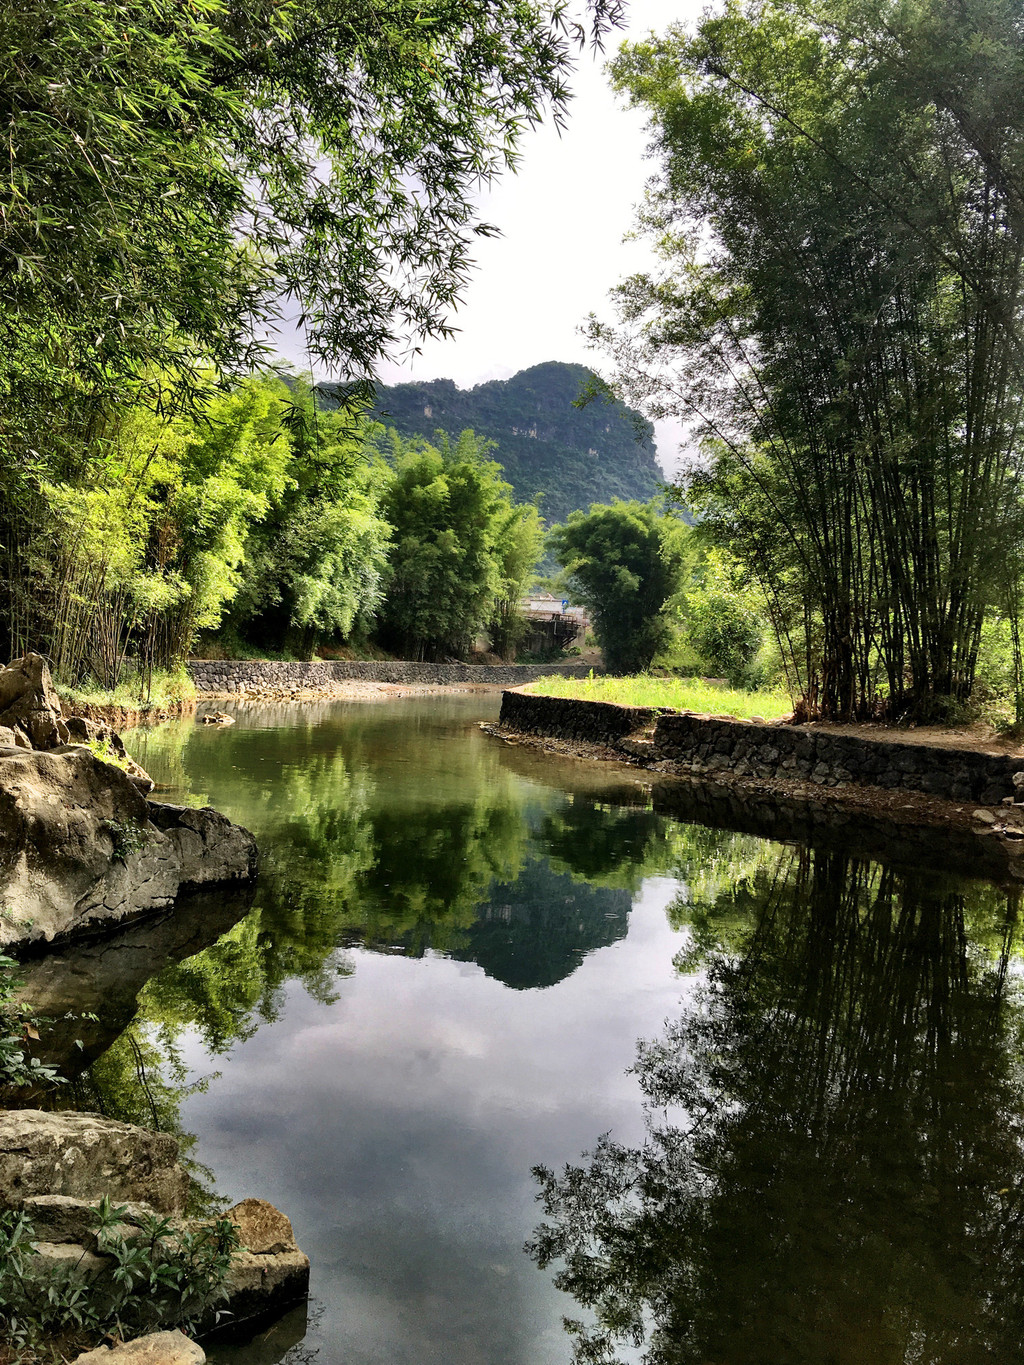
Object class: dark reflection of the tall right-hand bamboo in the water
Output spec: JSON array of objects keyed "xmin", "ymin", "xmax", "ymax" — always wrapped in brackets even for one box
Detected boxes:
[{"xmin": 530, "ymin": 849, "xmax": 1024, "ymax": 1365}]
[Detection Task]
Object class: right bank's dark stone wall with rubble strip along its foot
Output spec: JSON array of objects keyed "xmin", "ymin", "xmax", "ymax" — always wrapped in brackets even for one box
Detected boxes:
[{"xmin": 485, "ymin": 691, "xmax": 1024, "ymax": 879}]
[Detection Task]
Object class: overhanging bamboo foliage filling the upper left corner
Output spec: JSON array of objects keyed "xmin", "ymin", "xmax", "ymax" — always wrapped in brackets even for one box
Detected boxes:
[{"xmin": 0, "ymin": 0, "xmax": 620, "ymax": 666}]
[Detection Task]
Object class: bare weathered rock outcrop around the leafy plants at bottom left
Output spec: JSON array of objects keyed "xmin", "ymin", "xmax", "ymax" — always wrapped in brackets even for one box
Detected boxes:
[{"xmin": 0, "ymin": 1110, "xmax": 310, "ymax": 1337}]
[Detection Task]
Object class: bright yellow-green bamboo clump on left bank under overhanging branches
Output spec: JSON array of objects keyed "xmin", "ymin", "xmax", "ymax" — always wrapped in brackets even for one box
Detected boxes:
[{"xmin": 34, "ymin": 375, "xmax": 289, "ymax": 691}]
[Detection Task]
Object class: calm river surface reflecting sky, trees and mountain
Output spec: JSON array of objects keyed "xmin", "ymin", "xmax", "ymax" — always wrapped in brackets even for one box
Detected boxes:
[{"xmin": 46, "ymin": 695, "xmax": 1024, "ymax": 1365}]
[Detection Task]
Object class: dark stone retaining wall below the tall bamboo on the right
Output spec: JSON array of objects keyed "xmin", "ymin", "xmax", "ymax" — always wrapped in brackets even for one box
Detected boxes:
[{"xmin": 498, "ymin": 692, "xmax": 1024, "ymax": 805}]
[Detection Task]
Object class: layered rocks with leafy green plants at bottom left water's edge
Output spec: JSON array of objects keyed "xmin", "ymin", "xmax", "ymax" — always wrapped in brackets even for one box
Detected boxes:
[{"xmin": 0, "ymin": 1110, "xmax": 310, "ymax": 1358}]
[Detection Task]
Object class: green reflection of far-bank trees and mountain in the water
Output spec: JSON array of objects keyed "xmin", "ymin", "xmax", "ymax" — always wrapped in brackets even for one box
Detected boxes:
[{"xmin": 38, "ymin": 703, "xmax": 725, "ymax": 1233}]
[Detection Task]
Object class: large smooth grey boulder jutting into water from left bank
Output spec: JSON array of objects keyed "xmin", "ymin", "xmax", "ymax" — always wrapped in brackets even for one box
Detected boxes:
[{"xmin": 0, "ymin": 745, "xmax": 257, "ymax": 946}]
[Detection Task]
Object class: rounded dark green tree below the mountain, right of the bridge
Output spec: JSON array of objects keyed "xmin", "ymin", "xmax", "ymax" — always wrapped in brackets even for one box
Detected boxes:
[{"xmin": 550, "ymin": 502, "xmax": 687, "ymax": 673}]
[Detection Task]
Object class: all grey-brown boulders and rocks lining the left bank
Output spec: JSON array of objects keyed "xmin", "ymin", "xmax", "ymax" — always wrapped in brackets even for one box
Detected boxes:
[{"xmin": 0, "ymin": 655, "xmax": 309, "ymax": 1365}]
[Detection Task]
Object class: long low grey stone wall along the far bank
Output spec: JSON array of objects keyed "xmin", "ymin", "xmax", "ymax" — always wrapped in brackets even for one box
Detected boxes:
[{"xmin": 188, "ymin": 659, "xmax": 590, "ymax": 692}]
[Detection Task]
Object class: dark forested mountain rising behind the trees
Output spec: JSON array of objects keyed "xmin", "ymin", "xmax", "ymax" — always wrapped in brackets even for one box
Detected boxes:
[{"xmin": 360, "ymin": 360, "xmax": 665, "ymax": 524}]
